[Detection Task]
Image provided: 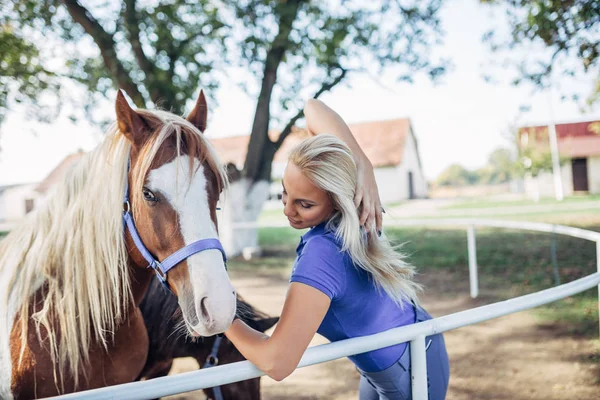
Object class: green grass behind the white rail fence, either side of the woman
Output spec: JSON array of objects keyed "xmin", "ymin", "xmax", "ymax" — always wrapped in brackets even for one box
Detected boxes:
[{"xmin": 232, "ymin": 225, "xmax": 600, "ymax": 338}]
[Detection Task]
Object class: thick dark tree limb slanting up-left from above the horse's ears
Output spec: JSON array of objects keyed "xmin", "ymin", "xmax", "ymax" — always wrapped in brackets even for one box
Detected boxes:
[{"xmin": 61, "ymin": 0, "xmax": 146, "ymax": 107}]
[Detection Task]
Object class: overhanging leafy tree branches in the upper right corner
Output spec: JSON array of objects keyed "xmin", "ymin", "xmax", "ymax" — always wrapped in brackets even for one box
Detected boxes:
[{"xmin": 481, "ymin": 0, "xmax": 600, "ymax": 104}]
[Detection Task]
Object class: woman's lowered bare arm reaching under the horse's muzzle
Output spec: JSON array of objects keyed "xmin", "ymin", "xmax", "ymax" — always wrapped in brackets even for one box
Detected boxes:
[{"xmin": 225, "ymin": 282, "xmax": 331, "ymax": 381}]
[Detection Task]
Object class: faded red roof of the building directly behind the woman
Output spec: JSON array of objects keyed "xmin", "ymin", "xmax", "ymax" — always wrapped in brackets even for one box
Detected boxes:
[{"xmin": 210, "ymin": 118, "xmax": 410, "ymax": 167}]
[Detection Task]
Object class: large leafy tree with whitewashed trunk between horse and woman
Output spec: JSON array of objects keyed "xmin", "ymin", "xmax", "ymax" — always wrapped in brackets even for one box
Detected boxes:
[{"xmin": 3, "ymin": 0, "xmax": 445, "ymax": 253}]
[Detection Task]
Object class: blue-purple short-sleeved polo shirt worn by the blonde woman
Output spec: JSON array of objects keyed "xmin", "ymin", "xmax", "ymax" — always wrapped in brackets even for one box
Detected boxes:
[{"xmin": 290, "ymin": 223, "xmax": 415, "ymax": 372}]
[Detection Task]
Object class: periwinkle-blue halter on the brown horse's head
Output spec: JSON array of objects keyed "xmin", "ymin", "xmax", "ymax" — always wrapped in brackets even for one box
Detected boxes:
[{"xmin": 123, "ymin": 161, "xmax": 227, "ymax": 290}]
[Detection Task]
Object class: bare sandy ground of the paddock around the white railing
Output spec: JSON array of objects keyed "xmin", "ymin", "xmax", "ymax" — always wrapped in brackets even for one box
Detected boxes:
[{"xmin": 169, "ymin": 272, "xmax": 600, "ymax": 400}]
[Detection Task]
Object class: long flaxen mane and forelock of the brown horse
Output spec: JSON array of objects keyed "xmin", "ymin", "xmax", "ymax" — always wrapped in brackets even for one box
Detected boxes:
[{"xmin": 0, "ymin": 110, "xmax": 227, "ymax": 391}]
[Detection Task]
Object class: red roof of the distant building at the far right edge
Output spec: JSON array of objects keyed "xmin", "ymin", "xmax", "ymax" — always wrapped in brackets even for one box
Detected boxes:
[{"xmin": 519, "ymin": 121, "xmax": 600, "ymax": 158}]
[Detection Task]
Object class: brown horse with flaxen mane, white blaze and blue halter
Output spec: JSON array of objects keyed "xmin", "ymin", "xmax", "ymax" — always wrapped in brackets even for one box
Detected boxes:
[{"xmin": 0, "ymin": 91, "xmax": 236, "ymax": 399}]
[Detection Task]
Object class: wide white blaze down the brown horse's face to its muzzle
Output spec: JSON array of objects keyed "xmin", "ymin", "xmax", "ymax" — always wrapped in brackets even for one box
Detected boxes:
[{"xmin": 147, "ymin": 155, "xmax": 236, "ymax": 336}]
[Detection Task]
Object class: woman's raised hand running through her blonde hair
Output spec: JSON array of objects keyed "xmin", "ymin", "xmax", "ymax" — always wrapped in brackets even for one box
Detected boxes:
[{"xmin": 354, "ymin": 156, "xmax": 383, "ymax": 235}]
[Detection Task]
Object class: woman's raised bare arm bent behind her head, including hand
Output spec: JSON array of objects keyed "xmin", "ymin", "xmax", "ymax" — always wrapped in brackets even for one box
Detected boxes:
[{"xmin": 304, "ymin": 99, "xmax": 383, "ymax": 232}]
